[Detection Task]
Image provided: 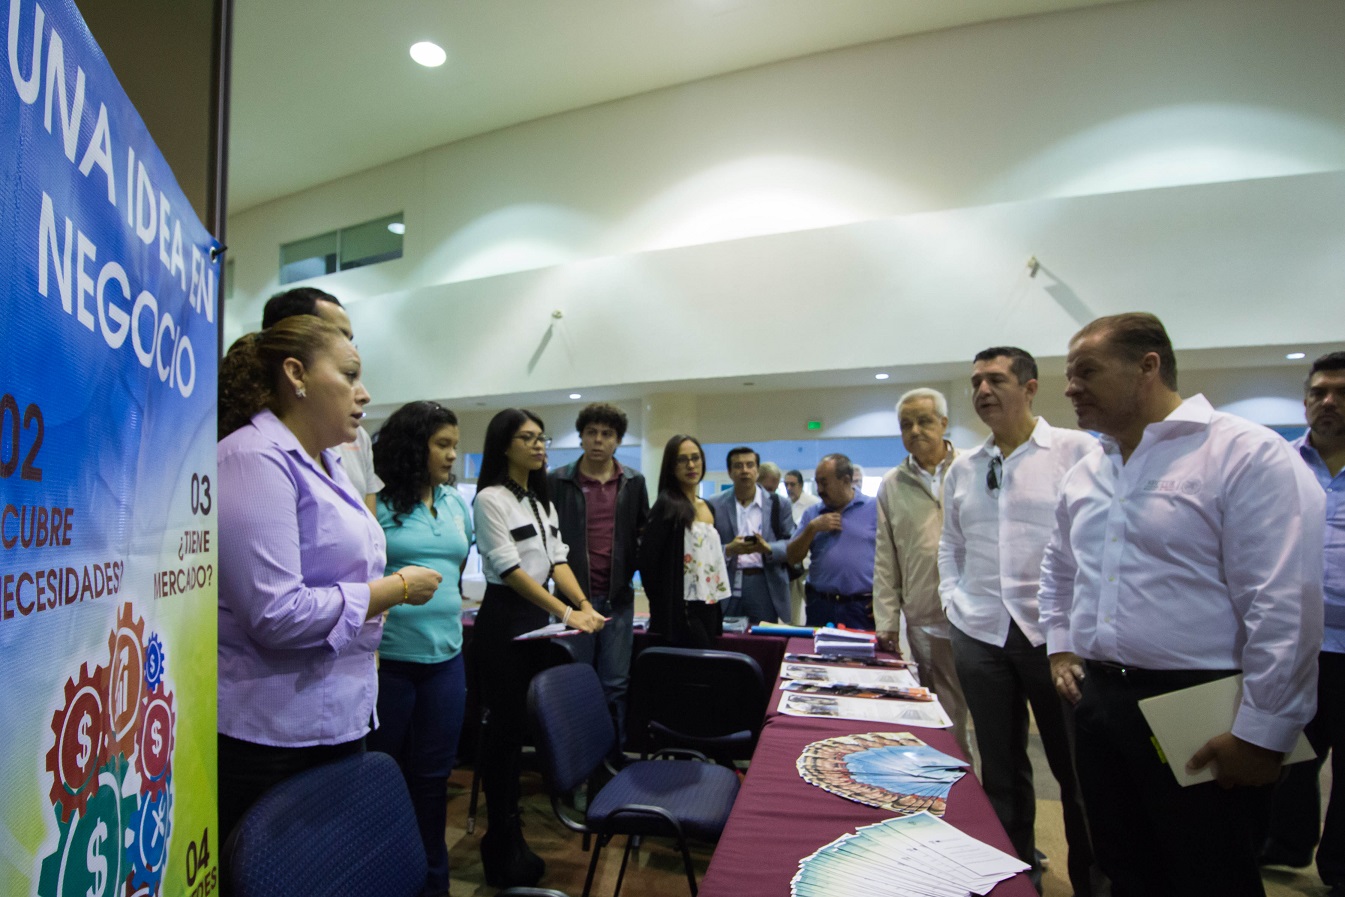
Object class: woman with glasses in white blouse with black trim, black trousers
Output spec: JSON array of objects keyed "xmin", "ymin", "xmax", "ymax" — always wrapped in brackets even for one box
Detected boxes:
[{"xmin": 472, "ymin": 407, "xmax": 603, "ymax": 888}]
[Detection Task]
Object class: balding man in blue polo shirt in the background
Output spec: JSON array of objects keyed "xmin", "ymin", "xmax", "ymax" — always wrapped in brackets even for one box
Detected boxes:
[{"xmin": 785, "ymin": 455, "xmax": 878, "ymax": 631}]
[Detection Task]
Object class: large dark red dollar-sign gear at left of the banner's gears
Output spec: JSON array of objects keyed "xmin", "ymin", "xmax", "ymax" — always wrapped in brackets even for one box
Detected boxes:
[{"xmin": 47, "ymin": 664, "xmax": 109, "ymax": 823}]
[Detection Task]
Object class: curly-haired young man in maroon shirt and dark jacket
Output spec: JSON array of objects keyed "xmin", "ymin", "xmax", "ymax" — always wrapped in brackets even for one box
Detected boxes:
[{"xmin": 549, "ymin": 402, "xmax": 650, "ymax": 737}]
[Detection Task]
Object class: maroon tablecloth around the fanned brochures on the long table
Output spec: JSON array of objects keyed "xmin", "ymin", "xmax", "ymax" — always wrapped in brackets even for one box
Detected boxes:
[{"xmin": 701, "ymin": 639, "xmax": 1037, "ymax": 897}]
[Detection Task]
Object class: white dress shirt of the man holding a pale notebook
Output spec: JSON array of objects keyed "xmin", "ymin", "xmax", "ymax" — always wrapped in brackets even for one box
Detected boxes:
[{"xmin": 1041, "ymin": 395, "xmax": 1325, "ymax": 750}]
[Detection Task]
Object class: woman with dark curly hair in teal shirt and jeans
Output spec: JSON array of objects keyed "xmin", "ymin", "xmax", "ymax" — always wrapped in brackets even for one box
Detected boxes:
[{"xmin": 369, "ymin": 402, "xmax": 472, "ymax": 897}]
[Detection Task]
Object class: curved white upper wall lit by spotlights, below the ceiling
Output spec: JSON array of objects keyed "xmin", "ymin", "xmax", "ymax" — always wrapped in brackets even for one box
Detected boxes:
[{"xmin": 226, "ymin": 0, "xmax": 1345, "ymax": 416}]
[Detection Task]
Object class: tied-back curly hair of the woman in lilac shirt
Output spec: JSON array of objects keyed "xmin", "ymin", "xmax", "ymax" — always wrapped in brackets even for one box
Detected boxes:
[{"xmin": 218, "ymin": 315, "xmax": 346, "ymax": 438}]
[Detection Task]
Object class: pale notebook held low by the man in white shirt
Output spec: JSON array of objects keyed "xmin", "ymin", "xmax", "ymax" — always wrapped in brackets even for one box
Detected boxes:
[{"xmin": 1139, "ymin": 674, "xmax": 1317, "ymax": 788}]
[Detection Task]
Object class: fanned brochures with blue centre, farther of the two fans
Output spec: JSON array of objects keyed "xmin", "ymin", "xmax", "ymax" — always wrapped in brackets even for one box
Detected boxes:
[{"xmin": 798, "ymin": 732, "xmax": 967, "ymax": 816}]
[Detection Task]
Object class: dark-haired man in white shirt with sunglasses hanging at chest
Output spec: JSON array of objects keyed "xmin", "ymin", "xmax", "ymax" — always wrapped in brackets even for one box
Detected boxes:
[{"xmin": 939, "ymin": 346, "xmax": 1098, "ymax": 897}]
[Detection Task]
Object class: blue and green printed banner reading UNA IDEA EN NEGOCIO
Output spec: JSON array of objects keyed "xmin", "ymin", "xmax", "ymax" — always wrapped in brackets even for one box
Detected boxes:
[{"xmin": 0, "ymin": 0, "xmax": 219, "ymax": 897}]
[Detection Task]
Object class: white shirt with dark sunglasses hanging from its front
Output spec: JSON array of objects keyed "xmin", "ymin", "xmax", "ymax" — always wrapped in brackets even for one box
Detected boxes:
[{"xmin": 939, "ymin": 417, "xmax": 1098, "ymax": 647}]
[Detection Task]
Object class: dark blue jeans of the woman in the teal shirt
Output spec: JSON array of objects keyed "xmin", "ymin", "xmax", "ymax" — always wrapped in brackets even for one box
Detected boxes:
[{"xmin": 369, "ymin": 654, "xmax": 467, "ymax": 894}]
